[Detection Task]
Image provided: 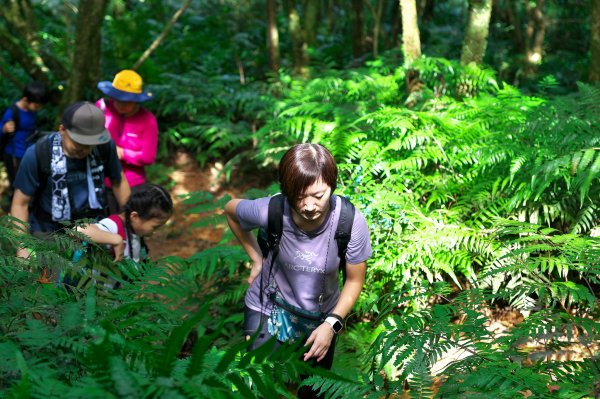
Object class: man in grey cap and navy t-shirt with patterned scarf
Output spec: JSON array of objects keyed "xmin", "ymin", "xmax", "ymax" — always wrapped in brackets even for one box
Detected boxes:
[{"xmin": 11, "ymin": 102, "xmax": 131, "ymax": 255}]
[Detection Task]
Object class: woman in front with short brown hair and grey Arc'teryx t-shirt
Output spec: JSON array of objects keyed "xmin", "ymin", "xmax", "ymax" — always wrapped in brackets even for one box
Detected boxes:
[{"xmin": 225, "ymin": 144, "xmax": 372, "ymax": 397}]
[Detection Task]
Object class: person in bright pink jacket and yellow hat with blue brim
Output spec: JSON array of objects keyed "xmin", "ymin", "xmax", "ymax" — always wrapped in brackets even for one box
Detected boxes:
[{"xmin": 96, "ymin": 69, "xmax": 158, "ymax": 212}]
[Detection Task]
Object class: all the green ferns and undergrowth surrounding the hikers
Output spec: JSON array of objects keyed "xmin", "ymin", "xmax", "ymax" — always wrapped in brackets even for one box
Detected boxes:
[{"xmin": 0, "ymin": 1, "xmax": 600, "ymax": 398}]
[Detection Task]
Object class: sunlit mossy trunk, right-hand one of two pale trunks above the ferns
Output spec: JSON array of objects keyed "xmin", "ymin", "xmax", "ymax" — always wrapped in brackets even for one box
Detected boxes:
[{"xmin": 460, "ymin": 0, "xmax": 492, "ymax": 65}]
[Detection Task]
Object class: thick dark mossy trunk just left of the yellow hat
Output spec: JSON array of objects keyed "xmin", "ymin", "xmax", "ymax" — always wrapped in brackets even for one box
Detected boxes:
[{"xmin": 60, "ymin": 0, "xmax": 106, "ymax": 109}]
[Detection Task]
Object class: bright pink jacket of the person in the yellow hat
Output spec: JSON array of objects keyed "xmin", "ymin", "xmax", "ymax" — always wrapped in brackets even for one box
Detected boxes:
[{"xmin": 96, "ymin": 98, "xmax": 158, "ymax": 187}]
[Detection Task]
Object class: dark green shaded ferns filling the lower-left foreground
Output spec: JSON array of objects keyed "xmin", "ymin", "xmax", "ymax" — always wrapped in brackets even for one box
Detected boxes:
[{"xmin": 0, "ymin": 217, "xmax": 314, "ymax": 398}]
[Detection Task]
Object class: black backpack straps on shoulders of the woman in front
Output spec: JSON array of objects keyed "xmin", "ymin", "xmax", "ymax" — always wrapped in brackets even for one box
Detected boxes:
[{"xmin": 257, "ymin": 194, "xmax": 355, "ymax": 282}]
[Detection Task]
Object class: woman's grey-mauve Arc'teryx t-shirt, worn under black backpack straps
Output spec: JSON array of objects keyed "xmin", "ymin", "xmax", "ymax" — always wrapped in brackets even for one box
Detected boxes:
[{"xmin": 236, "ymin": 195, "xmax": 372, "ymax": 315}]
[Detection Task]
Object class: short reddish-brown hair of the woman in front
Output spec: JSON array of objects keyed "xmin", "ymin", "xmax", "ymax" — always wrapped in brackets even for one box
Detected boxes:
[{"xmin": 279, "ymin": 143, "xmax": 338, "ymax": 202}]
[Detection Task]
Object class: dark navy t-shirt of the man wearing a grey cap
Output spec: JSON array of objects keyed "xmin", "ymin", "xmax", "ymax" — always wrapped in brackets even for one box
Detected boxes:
[{"xmin": 14, "ymin": 133, "xmax": 121, "ymax": 232}]
